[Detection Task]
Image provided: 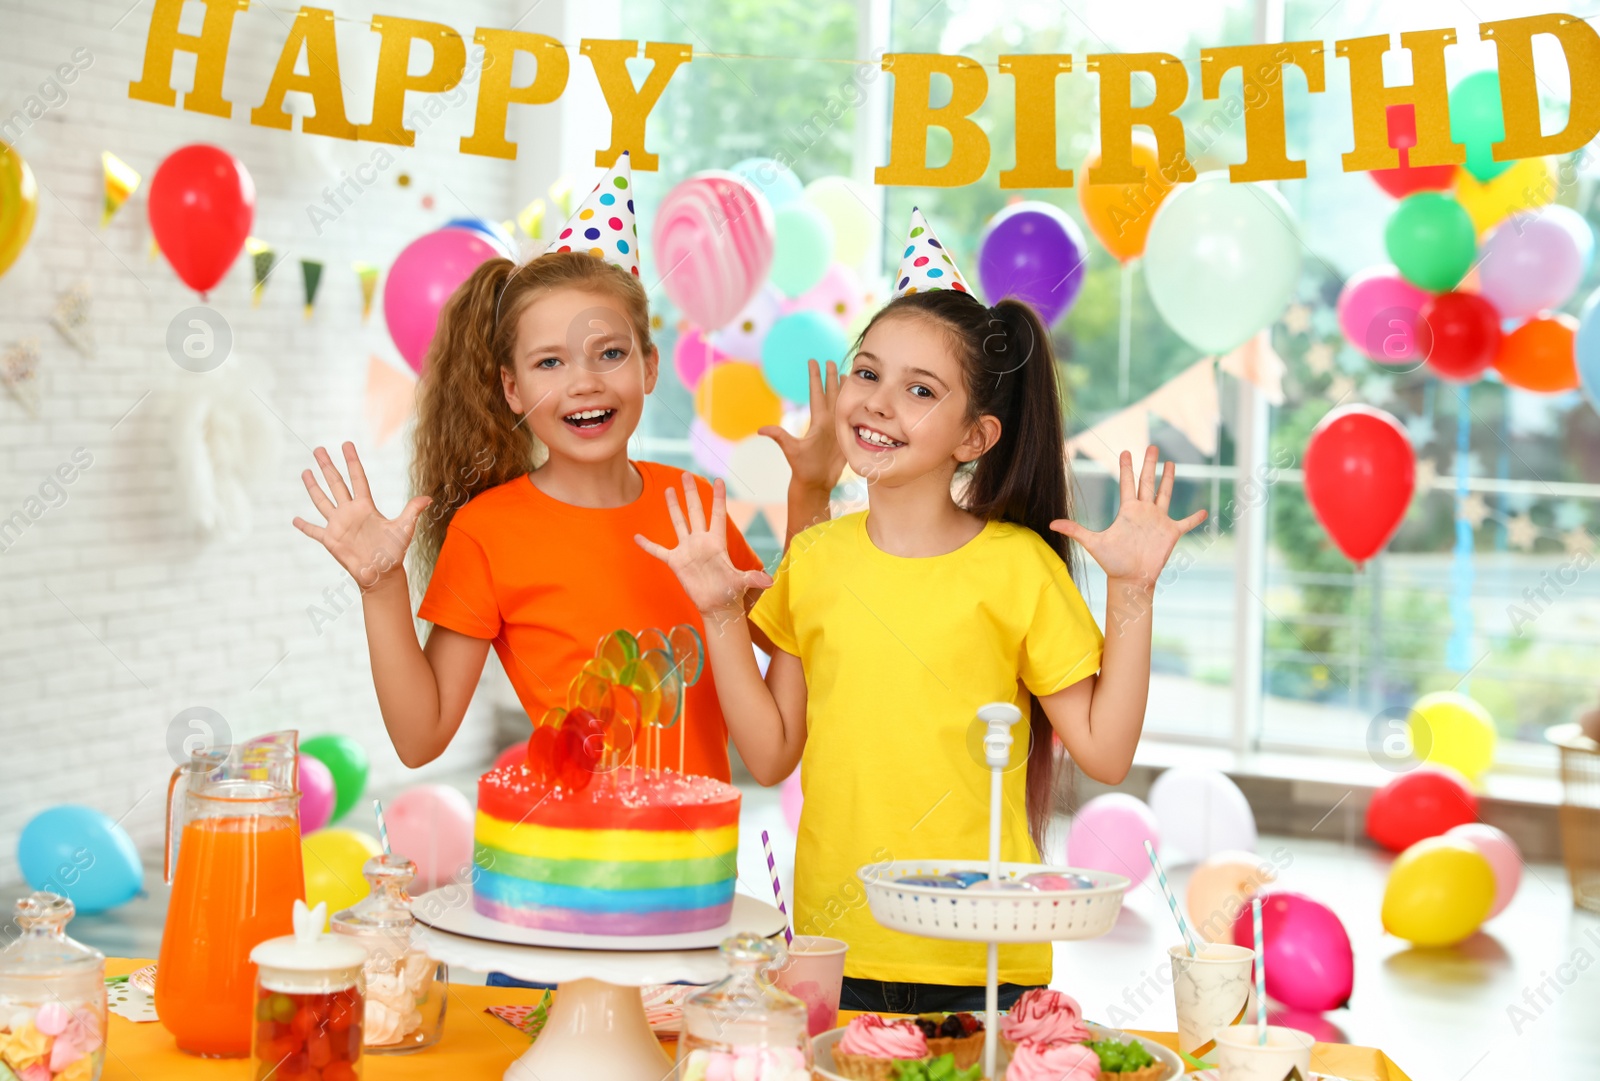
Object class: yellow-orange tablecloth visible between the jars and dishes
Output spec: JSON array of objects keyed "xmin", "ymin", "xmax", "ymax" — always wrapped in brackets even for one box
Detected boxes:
[{"xmin": 102, "ymin": 958, "xmax": 1410, "ymax": 1081}]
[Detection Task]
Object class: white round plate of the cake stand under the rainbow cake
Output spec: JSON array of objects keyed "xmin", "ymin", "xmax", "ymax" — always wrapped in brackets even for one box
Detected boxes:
[{"xmin": 411, "ymin": 884, "xmax": 787, "ymax": 953}]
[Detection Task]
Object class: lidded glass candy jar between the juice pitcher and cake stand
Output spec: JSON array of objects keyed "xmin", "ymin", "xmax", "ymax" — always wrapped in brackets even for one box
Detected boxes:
[{"xmin": 333, "ymin": 856, "xmax": 448, "ymax": 1054}]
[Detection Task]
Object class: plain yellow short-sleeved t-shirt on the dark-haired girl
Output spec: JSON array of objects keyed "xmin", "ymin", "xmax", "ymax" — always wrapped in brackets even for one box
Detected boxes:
[{"xmin": 752, "ymin": 512, "xmax": 1104, "ymax": 985}]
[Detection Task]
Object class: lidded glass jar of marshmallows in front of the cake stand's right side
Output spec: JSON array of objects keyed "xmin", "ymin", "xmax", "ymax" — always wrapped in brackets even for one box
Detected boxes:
[{"xmin": 678, "ymin": 934, "xmax": 811, "ymax": 1081}]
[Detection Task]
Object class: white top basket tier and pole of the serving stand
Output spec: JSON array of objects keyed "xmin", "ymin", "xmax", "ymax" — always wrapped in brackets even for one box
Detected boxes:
[{"xmin": 856, "ymin": 702, "xmax": 1131, "ymax": 1081}]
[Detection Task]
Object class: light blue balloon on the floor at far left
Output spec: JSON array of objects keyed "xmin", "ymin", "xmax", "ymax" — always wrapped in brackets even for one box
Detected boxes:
[{"xmin": 16, "ymin": 803, "xmax": 144, "ymax": 913}]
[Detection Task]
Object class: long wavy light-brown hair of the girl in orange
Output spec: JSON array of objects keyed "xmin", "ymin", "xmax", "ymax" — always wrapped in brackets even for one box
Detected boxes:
[{"xmin": 411, "ymin": 251, "xmax": 653, "ymax": 590}]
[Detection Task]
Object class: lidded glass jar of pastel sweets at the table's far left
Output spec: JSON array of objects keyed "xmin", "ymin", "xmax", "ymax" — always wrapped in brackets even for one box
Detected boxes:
[{"xmin": 0, "ymin": 892, "xmax": 106, "ymax": 1081}]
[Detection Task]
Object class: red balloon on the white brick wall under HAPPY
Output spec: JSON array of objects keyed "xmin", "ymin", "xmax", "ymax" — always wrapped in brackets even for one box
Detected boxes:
[{"xmin": 146, "ymin": 142, "xmax": 256, "ymax": 297}]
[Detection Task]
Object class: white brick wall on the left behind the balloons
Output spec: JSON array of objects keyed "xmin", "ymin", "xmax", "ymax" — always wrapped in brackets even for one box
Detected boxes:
[{"xmin": 0, "ymin": 0, "xmax": 616, "ymax": 881}]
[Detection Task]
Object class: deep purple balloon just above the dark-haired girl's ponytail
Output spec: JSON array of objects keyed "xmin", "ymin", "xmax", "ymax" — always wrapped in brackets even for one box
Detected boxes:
[{"xmin": 978, "ymin": 201, "xmax": 1088, "ymax": 326}]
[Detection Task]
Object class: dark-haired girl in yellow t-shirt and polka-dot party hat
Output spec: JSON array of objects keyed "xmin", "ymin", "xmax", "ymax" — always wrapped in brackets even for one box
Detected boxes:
[{"xmin": 638, "ymin": 214, "xmax": 1205, "ymax": 1012}]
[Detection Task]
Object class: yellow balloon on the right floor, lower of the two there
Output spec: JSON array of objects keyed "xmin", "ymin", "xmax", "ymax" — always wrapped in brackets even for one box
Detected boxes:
[{"xmin": 1382, "ymin": 836, "xmax": 1494, "ymax": 947}]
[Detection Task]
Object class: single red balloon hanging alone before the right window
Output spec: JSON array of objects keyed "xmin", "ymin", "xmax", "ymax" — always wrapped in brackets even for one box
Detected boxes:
[{"xmin": 1306, "ymin": 405, "xmax": 1416, "ymax": 563}]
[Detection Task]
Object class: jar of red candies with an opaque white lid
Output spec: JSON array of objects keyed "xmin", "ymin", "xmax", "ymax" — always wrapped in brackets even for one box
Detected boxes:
[{"xmin": 250, "ymin": 900, "xmax": 366, "ymax": 1081}]
